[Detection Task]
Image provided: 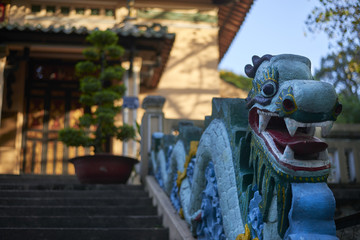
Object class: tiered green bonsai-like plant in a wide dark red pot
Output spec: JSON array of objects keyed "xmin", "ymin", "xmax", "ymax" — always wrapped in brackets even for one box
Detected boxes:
[{"xmin": 59, "ymin": 30, "xmax": 137, "ymax": 183}]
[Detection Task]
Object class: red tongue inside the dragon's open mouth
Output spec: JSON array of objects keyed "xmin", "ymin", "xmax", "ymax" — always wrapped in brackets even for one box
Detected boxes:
[{"xmin": 267, "ymin": 129, "xmax": 328, "ymax": 155}]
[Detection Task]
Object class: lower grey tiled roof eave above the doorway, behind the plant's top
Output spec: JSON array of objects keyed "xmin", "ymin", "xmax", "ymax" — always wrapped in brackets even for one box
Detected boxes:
[{"xmin": 0, "ymin": 23, "xmax": 175, "ymax": 88}]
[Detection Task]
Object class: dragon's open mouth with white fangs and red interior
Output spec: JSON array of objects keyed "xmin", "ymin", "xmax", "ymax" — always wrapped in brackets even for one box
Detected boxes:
[{"xmin": 249, "ymin": 108, "xmax": 333, "ymax": 172}]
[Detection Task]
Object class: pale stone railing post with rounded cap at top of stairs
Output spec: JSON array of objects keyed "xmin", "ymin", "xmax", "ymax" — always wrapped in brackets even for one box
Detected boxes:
[{"xmin": 140, "ymin": 96, "xmax": 165, "ymax": 180}]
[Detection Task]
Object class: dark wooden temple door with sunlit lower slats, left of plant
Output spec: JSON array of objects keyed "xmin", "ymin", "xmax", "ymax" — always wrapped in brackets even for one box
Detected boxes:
[{"xmin": 21, "ymin": 61, "xmax": 87, "ymax": 174}]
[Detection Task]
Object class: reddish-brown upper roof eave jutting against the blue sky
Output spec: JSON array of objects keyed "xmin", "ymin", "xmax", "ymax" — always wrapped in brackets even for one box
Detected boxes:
[{"xmin": 217, "ymin": 0, "xmax": 254, "ymax": 62}]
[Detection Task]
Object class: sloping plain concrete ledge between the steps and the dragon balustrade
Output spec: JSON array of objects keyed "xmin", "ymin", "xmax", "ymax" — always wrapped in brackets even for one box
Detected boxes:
[{"xmin": 145, "ymin": 176, "xmax": 195, "ymax": 240}]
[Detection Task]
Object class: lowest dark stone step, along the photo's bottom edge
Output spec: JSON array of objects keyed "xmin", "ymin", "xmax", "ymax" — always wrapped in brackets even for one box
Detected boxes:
[{"xmin": 0, "ymin": 228, "xmax": 169, "ymax": 240}]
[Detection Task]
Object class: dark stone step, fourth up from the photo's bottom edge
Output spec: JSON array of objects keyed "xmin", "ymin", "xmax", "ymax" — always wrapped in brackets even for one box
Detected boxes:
[{"xmin": 0, "ymin": 197, "xmax": 152, "ymax": 206}]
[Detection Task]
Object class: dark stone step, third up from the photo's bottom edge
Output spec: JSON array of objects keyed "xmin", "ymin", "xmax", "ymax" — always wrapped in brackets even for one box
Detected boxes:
[{"xmin": 0, "ymin": 205, "xmax": 157, "ymax": 218}]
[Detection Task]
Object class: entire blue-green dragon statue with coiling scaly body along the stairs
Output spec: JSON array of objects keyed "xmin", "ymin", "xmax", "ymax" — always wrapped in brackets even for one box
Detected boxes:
[{"xmin": 150, "ymin": 54, "xmax": 342, "ymax": 240}]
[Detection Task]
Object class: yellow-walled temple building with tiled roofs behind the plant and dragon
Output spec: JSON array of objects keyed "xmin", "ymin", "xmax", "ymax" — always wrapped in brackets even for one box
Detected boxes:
[{"xmin": 0, "ymin": 0, "xmax": 253, "ymax": 174}]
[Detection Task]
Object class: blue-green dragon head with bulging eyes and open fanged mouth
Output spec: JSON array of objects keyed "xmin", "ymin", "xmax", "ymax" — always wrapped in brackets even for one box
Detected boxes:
[{"xmin": 245, "ymin": 54, "xmax": 342, "ymax": 176}]
